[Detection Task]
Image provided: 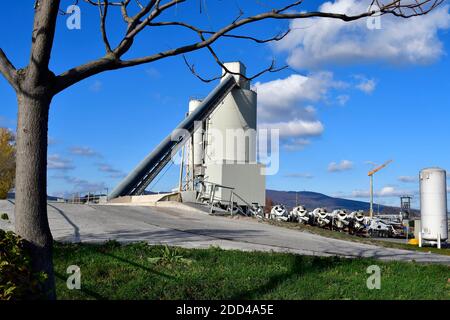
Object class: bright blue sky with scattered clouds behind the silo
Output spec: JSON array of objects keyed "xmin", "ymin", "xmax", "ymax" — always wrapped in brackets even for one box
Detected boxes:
[{"xmin": 0, "ymin": 0, "xmax": 450, "ymax": 206}]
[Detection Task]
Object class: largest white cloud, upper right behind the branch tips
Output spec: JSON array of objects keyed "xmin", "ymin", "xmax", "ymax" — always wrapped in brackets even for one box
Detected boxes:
[{"xmin": 274, "ymin": 0, "xmax": 450, "ymax": 69}]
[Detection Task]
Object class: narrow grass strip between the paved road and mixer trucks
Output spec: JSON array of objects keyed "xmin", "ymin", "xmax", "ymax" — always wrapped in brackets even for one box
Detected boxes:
[{"xmin": 264, "ymin": 220, "xmax": 450, "ymax": 256}]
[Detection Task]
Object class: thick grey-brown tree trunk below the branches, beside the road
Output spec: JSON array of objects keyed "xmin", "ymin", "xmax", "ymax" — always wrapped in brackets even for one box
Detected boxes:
[{"xmin": 15, "ymin": 92, "xmax": 56, "ymax": 299}]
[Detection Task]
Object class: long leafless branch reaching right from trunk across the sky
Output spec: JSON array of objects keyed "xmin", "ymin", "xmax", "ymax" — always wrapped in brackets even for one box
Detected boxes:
[{"xmin": 55, "ymin": 0, "xmax": 444, "ymax": 92}]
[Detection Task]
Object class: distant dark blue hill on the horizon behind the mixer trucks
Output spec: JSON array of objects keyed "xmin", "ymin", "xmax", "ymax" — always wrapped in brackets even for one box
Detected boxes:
[{"xmin": 266, "ymin": 190, "xmax": 419, "ymax": 215}]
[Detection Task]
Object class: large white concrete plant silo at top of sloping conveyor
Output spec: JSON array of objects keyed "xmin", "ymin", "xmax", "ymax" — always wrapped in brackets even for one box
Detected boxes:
[{"xmin": 204, "ymin": 62, "xmax": 266, "ymax": 206}]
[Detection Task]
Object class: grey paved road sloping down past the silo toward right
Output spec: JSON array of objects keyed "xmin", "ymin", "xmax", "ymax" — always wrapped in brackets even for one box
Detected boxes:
[{"xmin": 0, "ymin": 201, "xmax": 450, "ymax": 265}]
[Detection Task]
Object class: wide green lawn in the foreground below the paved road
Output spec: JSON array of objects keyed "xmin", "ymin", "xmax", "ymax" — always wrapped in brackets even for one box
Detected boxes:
[{"xmin": 54, "ymin": 242, "xmax": 450, "ymax": 299}]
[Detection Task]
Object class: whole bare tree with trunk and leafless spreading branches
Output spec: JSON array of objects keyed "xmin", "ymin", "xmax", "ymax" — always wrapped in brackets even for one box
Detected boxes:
[{"xmin": 0, "ymin": 0, "xmax": 443, "ymax": 298}]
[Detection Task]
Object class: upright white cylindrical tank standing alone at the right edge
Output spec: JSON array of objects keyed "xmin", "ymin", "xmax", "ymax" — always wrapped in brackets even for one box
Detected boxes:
[{"xmin": 419, "ymin": 168, "xmax": 448, "ymax": 241}]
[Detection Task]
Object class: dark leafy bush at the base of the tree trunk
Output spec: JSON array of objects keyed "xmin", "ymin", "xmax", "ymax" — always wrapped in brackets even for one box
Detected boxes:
[{"xmin": 0, "ymin": 229, "xmax": 46, "ymax": 300}]
